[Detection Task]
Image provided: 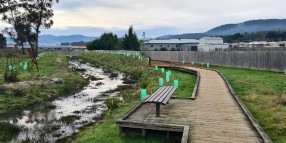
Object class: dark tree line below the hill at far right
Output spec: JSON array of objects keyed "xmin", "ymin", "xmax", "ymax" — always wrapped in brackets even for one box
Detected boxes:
[{"xmin": 223, "ymin": 31, "xmax": 286, "ymax": 43}]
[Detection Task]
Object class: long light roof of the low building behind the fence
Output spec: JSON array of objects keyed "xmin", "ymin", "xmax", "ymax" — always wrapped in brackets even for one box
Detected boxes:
[{"xmin": 144, "ymin": 39, "xmax": 199, "ymax": 44}]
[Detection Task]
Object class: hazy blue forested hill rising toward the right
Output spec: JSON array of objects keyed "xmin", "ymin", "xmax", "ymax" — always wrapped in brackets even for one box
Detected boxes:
[{"xmin": 158, "ymin": 19, "xmax": 286, "ymax": 39}]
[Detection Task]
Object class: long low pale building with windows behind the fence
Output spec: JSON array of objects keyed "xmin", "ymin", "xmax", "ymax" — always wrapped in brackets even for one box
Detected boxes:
[{"xmin": 140, "ymin": 39, "xmax": 199, "ymax": 51}]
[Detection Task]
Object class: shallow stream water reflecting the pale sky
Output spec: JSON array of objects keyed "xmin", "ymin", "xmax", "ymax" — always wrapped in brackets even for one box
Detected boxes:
[{"xmin": 5, "ymin": 61, "xmax": 123, "ymax": 142}]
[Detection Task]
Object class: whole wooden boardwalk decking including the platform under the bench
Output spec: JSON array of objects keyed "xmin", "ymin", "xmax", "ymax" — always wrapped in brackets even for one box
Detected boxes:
[{"xmin": 122, "ymin": 67, "xmax": 263, "ymax": 143}]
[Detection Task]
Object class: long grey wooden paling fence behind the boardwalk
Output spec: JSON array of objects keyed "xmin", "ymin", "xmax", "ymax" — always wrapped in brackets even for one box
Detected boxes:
[{"xmin": 143, "ymin": 51, "xmax": 286, "ymax": 72}]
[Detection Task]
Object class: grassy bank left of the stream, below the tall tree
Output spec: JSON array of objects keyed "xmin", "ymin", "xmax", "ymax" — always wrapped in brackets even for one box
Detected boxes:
[{"xmin": 0, "ymin": 53, "xmax": 87, "ymax": 114}]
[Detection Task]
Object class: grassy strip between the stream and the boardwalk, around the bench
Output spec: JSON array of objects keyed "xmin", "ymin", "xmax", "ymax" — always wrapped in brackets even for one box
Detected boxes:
[{"xmin": 74, "ymin": 53, "xmax": 196, "ymax": 143}]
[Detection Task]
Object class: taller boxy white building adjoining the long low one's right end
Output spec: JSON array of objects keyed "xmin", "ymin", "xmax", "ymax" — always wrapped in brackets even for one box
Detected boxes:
[{"xmin": 198, "ymin": 37, "xmax": 229, "ymax": 51}]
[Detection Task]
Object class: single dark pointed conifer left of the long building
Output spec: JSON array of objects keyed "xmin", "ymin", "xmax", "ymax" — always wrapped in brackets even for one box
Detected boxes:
[{"xmin": 123, "ymin": 25, "xmax": 140, "ymax": 51}]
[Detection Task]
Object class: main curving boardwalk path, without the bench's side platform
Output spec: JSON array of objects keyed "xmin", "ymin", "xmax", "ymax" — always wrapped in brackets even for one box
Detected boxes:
[{"xmin": 185, "ymin": 67, "xmax": 263, "ymax": 143}]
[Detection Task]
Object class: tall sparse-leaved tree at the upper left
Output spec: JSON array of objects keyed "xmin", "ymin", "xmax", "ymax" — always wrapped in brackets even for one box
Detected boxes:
[{"xmin": 0, "ymin": 0, "xmax": 59, "ymax": 56}]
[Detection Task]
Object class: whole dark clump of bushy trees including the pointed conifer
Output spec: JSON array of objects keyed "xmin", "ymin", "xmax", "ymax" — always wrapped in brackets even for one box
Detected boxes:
[{"xmin": 86, "ymin": 26, "xmax": 140, "ymax": 51}]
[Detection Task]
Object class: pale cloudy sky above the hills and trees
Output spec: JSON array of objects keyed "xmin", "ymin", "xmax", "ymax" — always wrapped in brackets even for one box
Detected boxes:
[{"xmin": 0, "ymin": 0, "xmax": 286, "ymax": 38}]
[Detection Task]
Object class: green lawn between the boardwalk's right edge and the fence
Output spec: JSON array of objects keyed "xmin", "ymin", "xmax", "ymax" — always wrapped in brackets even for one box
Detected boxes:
[{"xmin": 212, "ymin": 67, "xmax": 286, "ymax": 143}]
